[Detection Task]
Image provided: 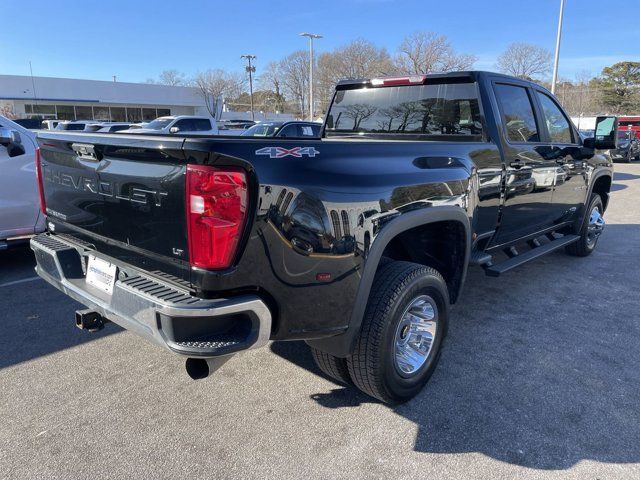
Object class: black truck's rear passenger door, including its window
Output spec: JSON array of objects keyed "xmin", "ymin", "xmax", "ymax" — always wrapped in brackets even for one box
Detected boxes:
[{"xmin": 492, "ymin": 79, "xmax": 557, "ymax": 246}]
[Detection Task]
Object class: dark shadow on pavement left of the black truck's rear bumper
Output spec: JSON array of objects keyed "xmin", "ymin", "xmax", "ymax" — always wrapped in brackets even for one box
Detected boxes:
[{"xmin": 0, "ymin": 247, "xmax": 122, "ymax": 369}]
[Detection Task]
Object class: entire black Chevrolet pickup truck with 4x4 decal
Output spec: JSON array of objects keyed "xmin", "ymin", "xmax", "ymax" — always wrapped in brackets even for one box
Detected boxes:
[{"xmin": 31, "ymin": 72, "xmax": 617, "ymax": 403}]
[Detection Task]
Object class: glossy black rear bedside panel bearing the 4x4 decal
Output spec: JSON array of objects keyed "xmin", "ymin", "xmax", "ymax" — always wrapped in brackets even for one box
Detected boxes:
[{"xmin": 185, "ymin": 139, "xmax": 501, "ymax": 339}]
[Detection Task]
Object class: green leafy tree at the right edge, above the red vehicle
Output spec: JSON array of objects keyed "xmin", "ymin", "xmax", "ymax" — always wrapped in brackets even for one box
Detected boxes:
[{"xmin": 593, "ymin": 62, "xmax": 640, "ymax": 114}]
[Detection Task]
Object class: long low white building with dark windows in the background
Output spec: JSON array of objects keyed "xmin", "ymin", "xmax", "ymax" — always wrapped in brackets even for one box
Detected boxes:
[{"xmin": 0, "ymin": 75, "xmax": 208, "ymax": 122}]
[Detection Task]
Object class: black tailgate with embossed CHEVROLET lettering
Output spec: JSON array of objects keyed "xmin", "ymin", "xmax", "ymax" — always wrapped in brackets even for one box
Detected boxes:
[{"xmin": 38, "ymin": 133, "xmax": 189, "ymax": 280}]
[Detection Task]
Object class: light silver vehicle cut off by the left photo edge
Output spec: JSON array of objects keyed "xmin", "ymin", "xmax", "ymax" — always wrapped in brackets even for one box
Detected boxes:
[{"xmin": 0, "ymin": 116, "xmax": 44, "ymax": 250}]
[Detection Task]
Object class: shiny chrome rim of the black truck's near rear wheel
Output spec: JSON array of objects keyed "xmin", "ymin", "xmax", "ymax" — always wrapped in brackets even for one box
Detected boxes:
[{"xmin": 394, "ymin": 295, "xmax": 438, "ymax": 377}]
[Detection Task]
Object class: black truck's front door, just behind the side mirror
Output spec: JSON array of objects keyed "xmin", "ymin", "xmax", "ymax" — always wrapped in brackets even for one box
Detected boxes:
[{"xmin": 535, "ymin": 89, "xmax": 588, "ymax": 224}]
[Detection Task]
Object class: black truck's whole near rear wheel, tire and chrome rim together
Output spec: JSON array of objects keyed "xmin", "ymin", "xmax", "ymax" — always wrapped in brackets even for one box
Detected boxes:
[{"xmin": 347, "ymin": 261, "xmax": 449, "ymax": 404}]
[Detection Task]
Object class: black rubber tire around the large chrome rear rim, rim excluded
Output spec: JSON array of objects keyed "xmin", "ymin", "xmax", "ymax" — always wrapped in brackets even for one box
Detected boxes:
[{"xmin": 347, "ymin": 261, "xmax": 449, "ymax": 404}]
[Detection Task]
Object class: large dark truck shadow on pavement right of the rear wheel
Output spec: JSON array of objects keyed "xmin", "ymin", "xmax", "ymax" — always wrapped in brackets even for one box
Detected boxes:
[{"xmin": 271, "ymin": 225, "xmax": 640, "ymax": 470}]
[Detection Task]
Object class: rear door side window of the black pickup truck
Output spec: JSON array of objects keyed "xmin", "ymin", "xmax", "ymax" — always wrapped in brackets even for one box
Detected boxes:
[{"xmin": 495, "ymin": 84, "xmax": 540, "ymax": 143}]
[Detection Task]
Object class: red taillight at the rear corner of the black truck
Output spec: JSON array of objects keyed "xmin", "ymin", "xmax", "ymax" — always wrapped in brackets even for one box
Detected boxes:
[{"xmin": 186, "ymin": 165, "xmax": 247, "ymax": 269}]
